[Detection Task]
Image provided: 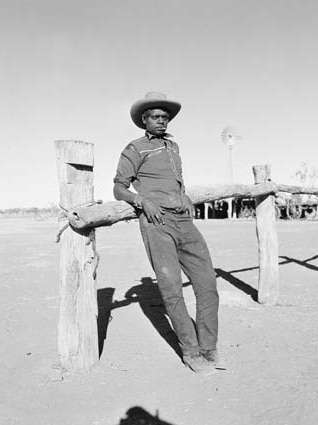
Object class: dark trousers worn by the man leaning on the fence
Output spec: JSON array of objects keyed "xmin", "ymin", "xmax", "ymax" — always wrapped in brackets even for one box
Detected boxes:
[{"xmin": 139, "ymin": 211, "xmax": 219, "ymax": 355}]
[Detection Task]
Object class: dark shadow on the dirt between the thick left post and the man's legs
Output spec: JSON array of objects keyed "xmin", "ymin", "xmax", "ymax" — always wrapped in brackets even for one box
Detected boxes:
[{"xmin": 97, "ymin": 277, "xmax": 181, "ymax": 359}]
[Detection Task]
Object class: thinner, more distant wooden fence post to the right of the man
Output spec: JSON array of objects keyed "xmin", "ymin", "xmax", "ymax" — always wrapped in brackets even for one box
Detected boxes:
[{"xmin": 253, "ymin": 165, "xmax": 279, "ymax": 305}]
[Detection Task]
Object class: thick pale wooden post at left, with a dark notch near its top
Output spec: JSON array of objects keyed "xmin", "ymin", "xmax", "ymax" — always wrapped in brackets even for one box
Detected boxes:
[{"xmin": 55, "ymin": 140, "xmax": 99, "ymax": 371}]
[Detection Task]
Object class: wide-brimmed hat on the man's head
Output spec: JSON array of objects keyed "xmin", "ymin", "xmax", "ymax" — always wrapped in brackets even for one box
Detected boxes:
[{"xmin": 130, "ymin": 92, "xmax": 181, "ymax": 129}]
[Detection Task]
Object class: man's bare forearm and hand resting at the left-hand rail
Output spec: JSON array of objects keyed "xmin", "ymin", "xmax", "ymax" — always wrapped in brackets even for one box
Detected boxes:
[{"xmin": 113, "ymin": 183, "xmax": 165, "ymax": 226}]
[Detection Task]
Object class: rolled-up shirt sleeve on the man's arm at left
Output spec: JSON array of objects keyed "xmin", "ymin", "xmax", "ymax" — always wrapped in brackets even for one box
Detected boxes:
[{"xmin": 114, "ymin": 144, "xmax": 141, "ymax": 188}]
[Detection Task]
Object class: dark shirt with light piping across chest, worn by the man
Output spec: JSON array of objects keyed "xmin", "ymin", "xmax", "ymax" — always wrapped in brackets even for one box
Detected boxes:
[{"xmin": 114, "ymin": 132, "xmax": 184, "ymax": 209}]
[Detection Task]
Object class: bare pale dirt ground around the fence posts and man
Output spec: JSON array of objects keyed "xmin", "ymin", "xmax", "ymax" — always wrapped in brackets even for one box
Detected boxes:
[{"xmin": 0, "ymin": 219, "xmax": 318, "ymax": 425}]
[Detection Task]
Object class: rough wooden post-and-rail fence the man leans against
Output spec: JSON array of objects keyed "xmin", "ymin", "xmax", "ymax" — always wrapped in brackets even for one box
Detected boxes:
[{"xmin": 55, "ymin": 140, "xmax": 318, "ymax": 370}]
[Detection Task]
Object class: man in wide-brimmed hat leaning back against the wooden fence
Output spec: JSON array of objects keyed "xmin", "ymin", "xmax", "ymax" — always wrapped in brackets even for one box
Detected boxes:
[{"xmin": 114, "ymin": 92, "xmax": 219, "ymax": 374}]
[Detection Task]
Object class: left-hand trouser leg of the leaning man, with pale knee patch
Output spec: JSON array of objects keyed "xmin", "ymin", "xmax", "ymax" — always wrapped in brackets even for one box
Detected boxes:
[{"xmin": 140, "ymin": 212, "xmax": 199, "ymax": 355}]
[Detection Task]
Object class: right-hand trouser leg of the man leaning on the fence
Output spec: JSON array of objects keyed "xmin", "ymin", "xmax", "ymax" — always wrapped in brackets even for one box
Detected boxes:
[{"xmin": 179, "ymin": 220, "xmax": 219, "ymax": 351}]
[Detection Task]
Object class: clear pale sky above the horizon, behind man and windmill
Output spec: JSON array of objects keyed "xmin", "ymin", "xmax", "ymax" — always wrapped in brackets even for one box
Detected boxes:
[{"xmin": 0, "ymin": 0, "xmax": 318, "ymax": 209}]
